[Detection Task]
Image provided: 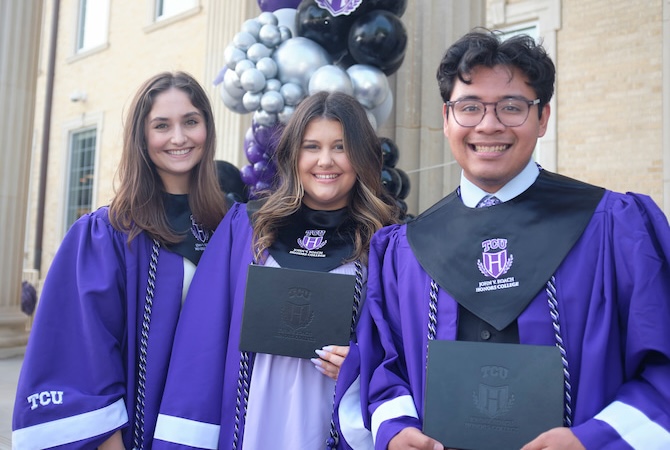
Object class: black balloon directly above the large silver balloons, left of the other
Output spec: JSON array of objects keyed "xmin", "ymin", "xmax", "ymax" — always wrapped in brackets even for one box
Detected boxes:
[{"xmin": 295, "ymin": 0, "xmax": 353, "ymax": 59}]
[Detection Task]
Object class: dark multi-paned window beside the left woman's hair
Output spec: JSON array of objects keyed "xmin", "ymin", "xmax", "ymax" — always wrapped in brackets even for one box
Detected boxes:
[{"xmin": 65, "ymin": 129, "xmax": 97, "ymax": 229}]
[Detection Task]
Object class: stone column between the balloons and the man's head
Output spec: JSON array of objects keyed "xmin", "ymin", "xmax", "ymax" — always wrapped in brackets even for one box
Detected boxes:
[{"xmin": 378, "ymin": 0, "xmax": 486, "ymax": 214}]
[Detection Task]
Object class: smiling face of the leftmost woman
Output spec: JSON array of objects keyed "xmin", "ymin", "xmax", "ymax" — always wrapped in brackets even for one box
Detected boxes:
[{"xmin": 144, "ymin": 88, "xmax": 207, "ymax": 194}]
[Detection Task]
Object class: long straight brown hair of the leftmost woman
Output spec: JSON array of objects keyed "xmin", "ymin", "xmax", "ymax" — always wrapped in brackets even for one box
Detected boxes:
[{"xmin": 109, "ymin": 72, "xmax": 226, "ymax": 244}]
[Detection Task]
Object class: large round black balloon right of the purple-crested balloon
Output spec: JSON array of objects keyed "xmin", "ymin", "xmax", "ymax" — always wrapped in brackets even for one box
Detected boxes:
[{"xmin": 348, "ymin": 9, "xmax": 407, "ymax": 75}]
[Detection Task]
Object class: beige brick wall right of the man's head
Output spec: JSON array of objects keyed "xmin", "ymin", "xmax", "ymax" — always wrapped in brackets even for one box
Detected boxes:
[{"xmin": 554, "ymin": 0, "xmax": 663, "ymax": 201}]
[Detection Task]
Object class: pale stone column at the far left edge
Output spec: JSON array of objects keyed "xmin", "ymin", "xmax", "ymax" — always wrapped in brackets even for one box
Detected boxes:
[{"xmin": 0, "ymin": 0, "xmax": 43, "ymax": 356}]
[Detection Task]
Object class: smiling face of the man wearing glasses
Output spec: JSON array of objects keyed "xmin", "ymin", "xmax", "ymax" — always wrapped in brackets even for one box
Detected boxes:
[{"xmin": 442, "ymin": 66, "xmax": 549, "ymax": 193}]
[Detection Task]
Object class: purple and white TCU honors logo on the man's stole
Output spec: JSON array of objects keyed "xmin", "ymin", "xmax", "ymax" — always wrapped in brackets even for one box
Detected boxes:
[{"xmin": 475, "ymin": 238, "xmax": 519, "ymax": 292}]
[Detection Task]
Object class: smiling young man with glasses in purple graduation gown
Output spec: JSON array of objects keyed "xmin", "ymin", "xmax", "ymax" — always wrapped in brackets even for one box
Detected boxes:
[{"xmin": 337, "ymin": 31, "xmax": 670, "ymax": 450}]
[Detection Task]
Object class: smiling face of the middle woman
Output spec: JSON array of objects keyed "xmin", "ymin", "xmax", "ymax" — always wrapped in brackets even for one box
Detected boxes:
[{"xmin": 298, "ymin": 118, "xmax": 356, "ymax": 211}]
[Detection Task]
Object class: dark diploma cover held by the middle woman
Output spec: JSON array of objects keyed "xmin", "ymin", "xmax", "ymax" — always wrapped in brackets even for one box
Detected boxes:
[{"xmin": 240, "ymin": 265, "xmax": 356, "ymax": 358}]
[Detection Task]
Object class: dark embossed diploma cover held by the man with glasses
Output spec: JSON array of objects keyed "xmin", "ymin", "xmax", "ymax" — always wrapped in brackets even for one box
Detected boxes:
[{"xmin": 423, "ymin": 341, "xmax": 563, "ymax": 450}]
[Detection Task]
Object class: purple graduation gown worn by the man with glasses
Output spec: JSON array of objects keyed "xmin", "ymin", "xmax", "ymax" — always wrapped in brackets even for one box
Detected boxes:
[{"xmin": 337, "ymin": 191, "xmax": 670, "ymax": 450}]
